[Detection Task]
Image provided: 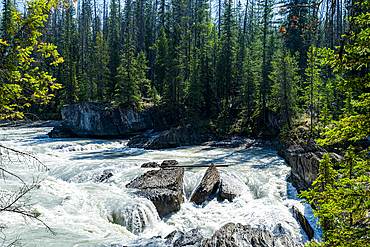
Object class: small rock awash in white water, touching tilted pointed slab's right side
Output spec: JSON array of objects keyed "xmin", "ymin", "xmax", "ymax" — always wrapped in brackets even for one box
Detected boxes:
[{"xmin": 219, "ymin": 171, "xmax": 249, "ymax": 201}]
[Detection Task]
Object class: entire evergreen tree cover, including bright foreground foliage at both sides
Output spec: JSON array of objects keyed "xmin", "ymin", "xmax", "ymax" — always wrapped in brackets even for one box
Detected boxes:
[{"xmin": 0, "ymin": 0, "xmax": 370, "ymax": 246}]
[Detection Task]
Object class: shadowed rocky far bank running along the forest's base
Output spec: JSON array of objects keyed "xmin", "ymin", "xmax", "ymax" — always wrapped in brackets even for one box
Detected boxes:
[{"xmin": 49, "ymin": 102, "xmax": 342, "ymax": 190}]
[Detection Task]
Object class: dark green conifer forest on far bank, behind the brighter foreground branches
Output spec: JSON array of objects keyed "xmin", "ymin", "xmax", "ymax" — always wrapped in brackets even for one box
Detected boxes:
[{"xmin": 1, "ymin": 0, "xmax": 358, "ymax": 137}]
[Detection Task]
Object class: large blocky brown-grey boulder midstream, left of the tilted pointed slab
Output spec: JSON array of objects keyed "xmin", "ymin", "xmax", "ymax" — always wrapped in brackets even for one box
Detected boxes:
[{"xmin": 126, "ymin": 168, "xmax": 184, "ymax": 218}]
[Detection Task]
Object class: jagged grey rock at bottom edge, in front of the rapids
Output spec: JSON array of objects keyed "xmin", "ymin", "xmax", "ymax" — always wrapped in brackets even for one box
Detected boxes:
[{"xmin": 202, "ymin": 223, "xmax": 303, "ymax": 247}]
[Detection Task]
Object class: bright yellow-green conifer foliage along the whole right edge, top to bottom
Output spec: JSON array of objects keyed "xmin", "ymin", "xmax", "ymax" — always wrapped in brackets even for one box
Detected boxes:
[{"xmin": 301, "ymin": 0, "xmax": 370, "ymax": 246}]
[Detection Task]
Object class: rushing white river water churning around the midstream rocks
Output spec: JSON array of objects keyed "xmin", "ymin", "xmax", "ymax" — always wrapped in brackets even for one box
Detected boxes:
[{"xmin": 0, "ymin": 128, "xmax": 320, "ymax": 246}]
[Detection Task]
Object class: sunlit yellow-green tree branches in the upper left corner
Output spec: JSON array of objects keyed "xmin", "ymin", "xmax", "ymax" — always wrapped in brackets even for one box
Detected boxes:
[{"xmin": 0, "ymin": 0, "xmax": 63, "ymax": 119}]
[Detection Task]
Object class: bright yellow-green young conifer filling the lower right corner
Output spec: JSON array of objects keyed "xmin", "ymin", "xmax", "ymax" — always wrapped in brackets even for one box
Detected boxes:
[{"xmin": 300, "ymin": 150, "xmax": 370, "ymax": 246}]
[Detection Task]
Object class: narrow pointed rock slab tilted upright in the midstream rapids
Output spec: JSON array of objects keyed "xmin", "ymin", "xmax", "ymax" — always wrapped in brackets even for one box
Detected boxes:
[{"xmin": 190, "ymin": 163, "xmax": 220, "ymax": 205}]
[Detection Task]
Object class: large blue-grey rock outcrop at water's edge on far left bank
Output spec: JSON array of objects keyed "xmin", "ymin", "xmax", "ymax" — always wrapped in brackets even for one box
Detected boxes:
[{"xmin": 49, "ymin": 102, "xmax": 163, "ymax": 138}]
